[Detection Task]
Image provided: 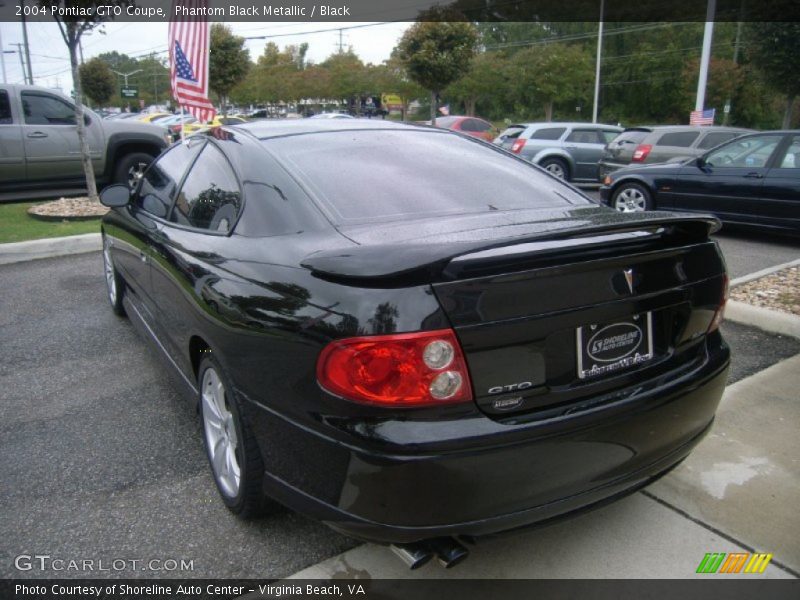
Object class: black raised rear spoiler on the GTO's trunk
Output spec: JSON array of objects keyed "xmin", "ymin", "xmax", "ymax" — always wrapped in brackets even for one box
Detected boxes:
[{"xmin": 300, "ymin": 212, "xmax": 721, "ymax": 287}]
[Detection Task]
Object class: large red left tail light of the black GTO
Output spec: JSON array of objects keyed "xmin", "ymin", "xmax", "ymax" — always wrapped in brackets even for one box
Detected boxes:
[{"xmin": 317, "ymin": 329, "xmax": 472, "ymax": 408}]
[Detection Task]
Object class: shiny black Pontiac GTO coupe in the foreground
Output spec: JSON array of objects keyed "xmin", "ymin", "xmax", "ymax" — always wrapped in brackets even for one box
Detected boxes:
[{"xmin": 102, "ymin": 120, "xmax": 729, "ymax": 564}]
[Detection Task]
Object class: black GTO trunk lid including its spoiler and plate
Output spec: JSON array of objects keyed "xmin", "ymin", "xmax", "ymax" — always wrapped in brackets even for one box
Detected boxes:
[{"xmin": 302, "ymin": 207, "xmax": 725, "ymax": 421}]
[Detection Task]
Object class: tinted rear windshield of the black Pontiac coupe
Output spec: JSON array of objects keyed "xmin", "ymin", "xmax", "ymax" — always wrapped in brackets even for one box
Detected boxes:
[{"xmin": 263, "ymin": 130, "xmax": 591, "ymax": 224}]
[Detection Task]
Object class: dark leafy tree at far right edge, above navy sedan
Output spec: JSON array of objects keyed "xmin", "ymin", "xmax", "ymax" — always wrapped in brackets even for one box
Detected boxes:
[{"xmin": 748, "ymin": 22, "xmax": 800, "ymax": 129}]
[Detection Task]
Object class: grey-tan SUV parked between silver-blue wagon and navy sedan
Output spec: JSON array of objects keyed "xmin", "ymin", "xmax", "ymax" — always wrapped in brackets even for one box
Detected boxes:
[{"xmin": 597, "ymin": 125, "xmax": 753, "ymax": 182}]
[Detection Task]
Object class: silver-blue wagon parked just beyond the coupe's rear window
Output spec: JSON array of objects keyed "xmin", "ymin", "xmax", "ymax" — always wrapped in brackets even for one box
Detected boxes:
[{"xmin": 494, "ymin": 123, "xmax": 622, "ymax": 182}]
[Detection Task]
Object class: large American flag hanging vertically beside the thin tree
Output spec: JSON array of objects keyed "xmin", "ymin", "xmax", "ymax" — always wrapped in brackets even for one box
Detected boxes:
[{"xmin": 169, "ymin": 0, "xmax": 217, "ymax": 123}]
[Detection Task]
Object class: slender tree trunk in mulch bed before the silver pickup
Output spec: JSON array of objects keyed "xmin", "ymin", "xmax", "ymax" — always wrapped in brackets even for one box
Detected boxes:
[{"xmin": 40, "ymin": 0, "xmax": 129, "ymax": 202}]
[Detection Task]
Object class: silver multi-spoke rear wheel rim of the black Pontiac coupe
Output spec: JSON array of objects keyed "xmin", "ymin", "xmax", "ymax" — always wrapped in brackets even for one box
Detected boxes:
[{"xmin": 201, "ymin": 367, "xmax": 241, "ymax": 498}]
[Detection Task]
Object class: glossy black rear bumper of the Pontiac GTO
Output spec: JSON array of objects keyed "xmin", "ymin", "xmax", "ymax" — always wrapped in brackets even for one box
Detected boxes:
[{"xmin": 247, "ymin": 336, "xmax": 729, "ymax": 543}]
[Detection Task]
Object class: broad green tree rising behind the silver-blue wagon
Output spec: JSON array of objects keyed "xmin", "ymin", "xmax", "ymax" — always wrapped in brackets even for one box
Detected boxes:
[{"xmin": 510, "ymin": 44, "xmax": 594, "ymax": 121}]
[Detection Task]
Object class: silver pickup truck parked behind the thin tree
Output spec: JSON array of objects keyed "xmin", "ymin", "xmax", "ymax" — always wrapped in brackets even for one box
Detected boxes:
[{"xmin": 0, "ymin": 84, "xmax": 167, "ymax": 200}]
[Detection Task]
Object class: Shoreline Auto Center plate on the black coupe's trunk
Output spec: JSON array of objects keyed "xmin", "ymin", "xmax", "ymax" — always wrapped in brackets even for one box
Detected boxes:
[{"xmin": 575, "ymin": 312, "xmax": 653, "ymax": 379}]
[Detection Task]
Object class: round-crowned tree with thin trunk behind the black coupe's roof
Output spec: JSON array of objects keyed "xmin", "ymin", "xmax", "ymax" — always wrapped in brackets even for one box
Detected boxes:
[{"xmin": 398, "ymin": 7, "xmax": 478, "ymax": 126}]
